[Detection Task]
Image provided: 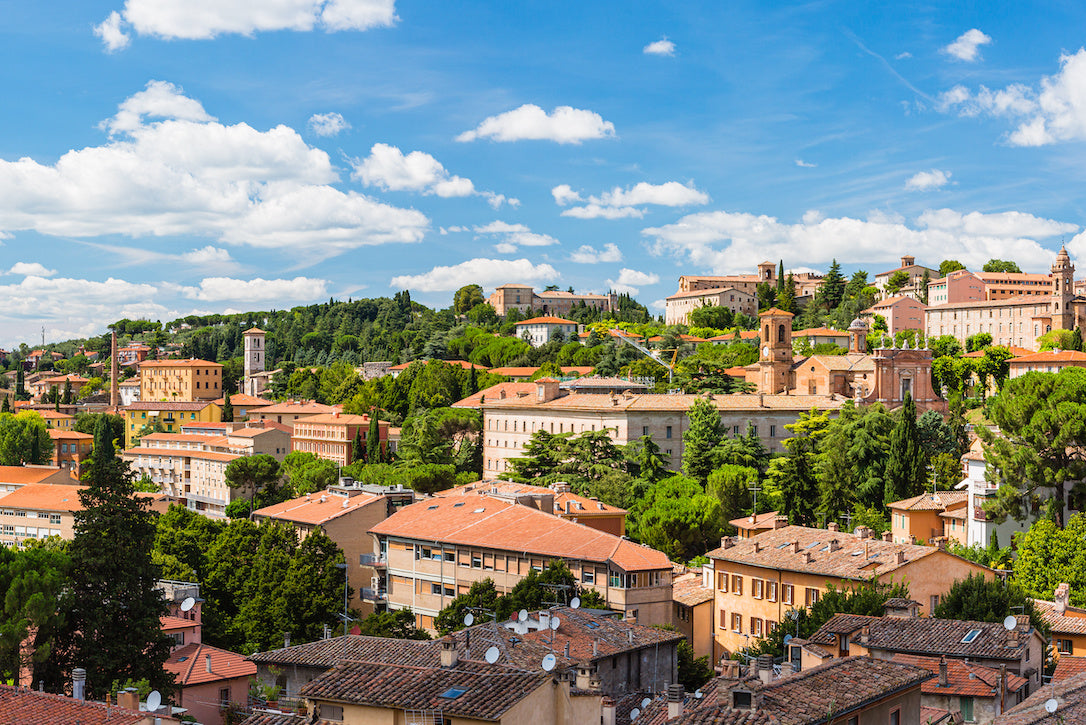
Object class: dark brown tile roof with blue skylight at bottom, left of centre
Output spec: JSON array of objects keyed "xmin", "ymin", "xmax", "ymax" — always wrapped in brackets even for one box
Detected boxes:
[{"xmin": 300, "ymin": 662, "xmax": 551, "ymax": 720}]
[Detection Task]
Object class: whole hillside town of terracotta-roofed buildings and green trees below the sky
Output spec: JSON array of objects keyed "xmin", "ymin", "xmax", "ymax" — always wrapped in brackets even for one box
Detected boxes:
[{"xmin": 0, "ymin": 249, "xmax": 1086, "ymax": 725}]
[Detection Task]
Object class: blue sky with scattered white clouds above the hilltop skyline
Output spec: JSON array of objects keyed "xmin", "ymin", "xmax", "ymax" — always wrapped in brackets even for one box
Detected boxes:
[{"xmin": 0, "ymin": 0, "xmax": 1086, "ymax": 345}]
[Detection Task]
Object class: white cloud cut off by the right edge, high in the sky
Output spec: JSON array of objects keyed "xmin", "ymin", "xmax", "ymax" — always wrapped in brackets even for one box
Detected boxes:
[{"xmin": 939, "ymin": 48, "xmax": 1086, "ymax": 147}]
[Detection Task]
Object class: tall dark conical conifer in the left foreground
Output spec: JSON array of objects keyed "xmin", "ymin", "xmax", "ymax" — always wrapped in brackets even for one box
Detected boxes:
[{"xmin": 52, "ymin": 416, "xmax": 173, "ymax": 699}]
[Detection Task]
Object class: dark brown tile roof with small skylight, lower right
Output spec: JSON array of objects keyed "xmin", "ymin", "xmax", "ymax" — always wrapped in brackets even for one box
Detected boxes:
[{"xmin": 810, "ymin": 614, "xmax": 1034, "ymax": 661}]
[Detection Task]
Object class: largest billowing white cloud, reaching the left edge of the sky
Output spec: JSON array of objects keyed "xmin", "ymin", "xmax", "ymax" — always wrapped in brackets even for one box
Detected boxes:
[{"xmin": 0, "ymin": 80, "xmax": 429, "ymax": 257}]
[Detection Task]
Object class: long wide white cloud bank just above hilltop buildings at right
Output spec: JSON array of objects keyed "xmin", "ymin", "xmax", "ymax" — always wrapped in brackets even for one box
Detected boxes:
[{"xmin": 642, "ymin": 208, "xmax": 1078, "ymax": 277}]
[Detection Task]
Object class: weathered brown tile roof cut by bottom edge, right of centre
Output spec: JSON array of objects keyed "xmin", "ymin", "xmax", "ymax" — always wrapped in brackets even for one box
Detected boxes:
[{"xmin": 664, "ymin": 657, "xmax": 932, "ymax": 725}]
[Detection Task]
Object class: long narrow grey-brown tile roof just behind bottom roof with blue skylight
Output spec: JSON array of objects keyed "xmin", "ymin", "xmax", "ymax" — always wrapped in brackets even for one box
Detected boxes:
[{"xmin": 249, "ymin": 635, "xmax": 441, "ymax": 670}]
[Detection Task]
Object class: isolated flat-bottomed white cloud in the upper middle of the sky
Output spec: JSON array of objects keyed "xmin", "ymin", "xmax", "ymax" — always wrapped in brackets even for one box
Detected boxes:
[{"xmin": 456, "ymin": 103, "xmax": 615, "ymax": 143}]
